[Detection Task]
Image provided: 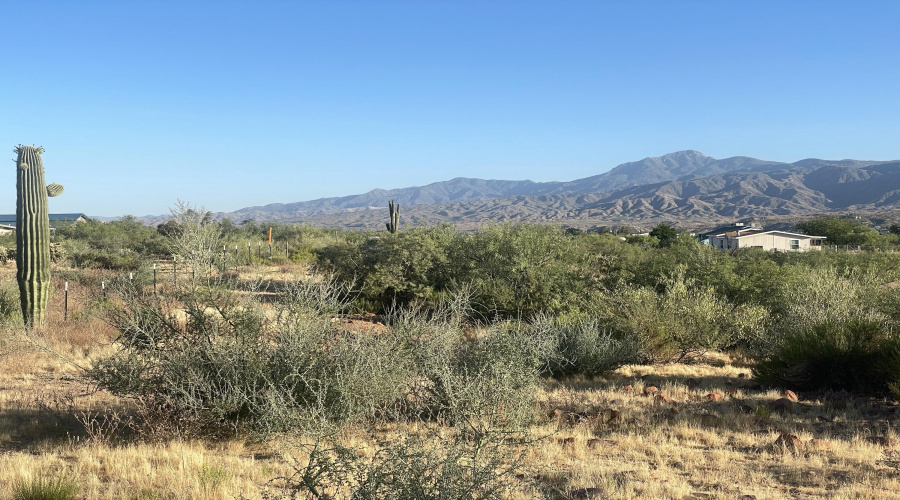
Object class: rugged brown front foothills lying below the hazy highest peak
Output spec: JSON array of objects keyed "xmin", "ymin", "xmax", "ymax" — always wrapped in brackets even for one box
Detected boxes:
[{"xmin": 276, "ymin": 162, "xmax": 900, "ymax": 229}]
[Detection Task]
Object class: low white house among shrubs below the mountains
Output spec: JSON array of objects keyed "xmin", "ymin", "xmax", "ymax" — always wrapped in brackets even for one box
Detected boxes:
[{"xmin": 702, "ymin": 223, "xmax": 825, "ymax": 252}]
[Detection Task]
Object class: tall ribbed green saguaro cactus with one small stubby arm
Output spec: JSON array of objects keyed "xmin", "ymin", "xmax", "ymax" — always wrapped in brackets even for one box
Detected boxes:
[{"xmin": 13, "ymin": 144, "xmax": 63, "ymax": 327}]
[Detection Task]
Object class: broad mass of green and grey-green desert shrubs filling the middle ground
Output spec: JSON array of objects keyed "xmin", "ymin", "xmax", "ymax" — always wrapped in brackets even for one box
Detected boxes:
[{"xmin": 0, "ymin": 210, "xmax": 900, "ymax": 498}]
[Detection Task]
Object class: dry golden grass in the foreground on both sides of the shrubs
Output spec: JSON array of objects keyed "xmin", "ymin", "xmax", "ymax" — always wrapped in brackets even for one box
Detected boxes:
[{"xmin": 0, "ymin": 266, "xmax": 900, "ymax": 500}]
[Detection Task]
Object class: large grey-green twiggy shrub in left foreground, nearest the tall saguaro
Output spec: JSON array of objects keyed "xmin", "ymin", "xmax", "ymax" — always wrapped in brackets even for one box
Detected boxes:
[{"xmin": 90, "ymin": 278, "xmax": 410, "ymax": 433}]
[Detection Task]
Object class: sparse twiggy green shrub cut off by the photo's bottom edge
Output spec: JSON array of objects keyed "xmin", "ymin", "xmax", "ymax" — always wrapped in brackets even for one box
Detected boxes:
[{"xmin": 270, "ymin": 423, "xmax": 530, "ymax": 500}]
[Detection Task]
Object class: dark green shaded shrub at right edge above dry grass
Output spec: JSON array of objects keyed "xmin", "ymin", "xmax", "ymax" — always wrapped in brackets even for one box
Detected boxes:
[{"xmin": 753, "ymin": 319, "xmax": 900, "ymax": 392}]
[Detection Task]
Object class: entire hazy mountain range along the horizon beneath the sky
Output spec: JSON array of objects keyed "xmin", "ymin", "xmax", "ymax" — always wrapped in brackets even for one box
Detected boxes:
[{"xmin": 139, "ymin": 151, "xmax": 900, "ymax": 230}]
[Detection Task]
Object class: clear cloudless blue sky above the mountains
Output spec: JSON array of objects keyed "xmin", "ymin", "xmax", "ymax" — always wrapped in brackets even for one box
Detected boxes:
[{"xmin": 0, "ymin": 0, "xmax": 900, "ymax": 216}]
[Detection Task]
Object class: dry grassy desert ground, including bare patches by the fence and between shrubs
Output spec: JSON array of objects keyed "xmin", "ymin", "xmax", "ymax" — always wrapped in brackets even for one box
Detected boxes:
[{"xmin": 0, "ymin": 216, "xmax": 900, "ymax": 500}]
